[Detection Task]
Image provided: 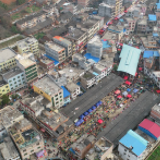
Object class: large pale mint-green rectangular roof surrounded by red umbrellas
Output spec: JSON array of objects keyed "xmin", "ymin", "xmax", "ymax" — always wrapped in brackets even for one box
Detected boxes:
[{"xmin": 118, "ymin": 44, "xmax": 141, "ymax": 76}]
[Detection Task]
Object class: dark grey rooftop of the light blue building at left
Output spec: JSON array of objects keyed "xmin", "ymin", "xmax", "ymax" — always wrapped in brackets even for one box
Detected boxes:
[{"xmin": 3, "ymin": 66, "xmax": 23, "ymax": 79}]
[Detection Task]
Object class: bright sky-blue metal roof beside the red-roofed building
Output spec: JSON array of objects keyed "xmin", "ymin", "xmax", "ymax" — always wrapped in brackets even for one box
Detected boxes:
[{"xmin": 119, "ymin": 130, "xmax": 148, "ymax": 156}]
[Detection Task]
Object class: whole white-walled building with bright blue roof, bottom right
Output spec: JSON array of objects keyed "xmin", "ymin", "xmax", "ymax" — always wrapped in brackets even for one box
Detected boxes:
[{"xmin": 118, "ymin": 130, "xmax": 148, "ymax": 160}]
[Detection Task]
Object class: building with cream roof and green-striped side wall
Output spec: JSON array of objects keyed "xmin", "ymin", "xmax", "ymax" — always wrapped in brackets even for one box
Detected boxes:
[{"xmin": 16, "ymin": 53, "xmax": 38, "ymax": 83}]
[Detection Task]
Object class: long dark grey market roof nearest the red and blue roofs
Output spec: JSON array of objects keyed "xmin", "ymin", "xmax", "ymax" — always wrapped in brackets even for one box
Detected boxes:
[{"xmin": 97, "ymin": 91, "xmax": 160, "ymax": 147}]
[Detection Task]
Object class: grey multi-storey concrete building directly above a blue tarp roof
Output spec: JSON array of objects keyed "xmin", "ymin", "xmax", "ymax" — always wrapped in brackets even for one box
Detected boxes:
[{"xmin": 87, "ymin": 36, "xmax": 103, "ymax": 59}]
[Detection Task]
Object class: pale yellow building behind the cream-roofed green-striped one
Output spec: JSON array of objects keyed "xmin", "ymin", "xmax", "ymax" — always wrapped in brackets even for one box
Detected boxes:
[{"xmin": 17, "ymin": 37, "xmax": 39, "ymax": 56}]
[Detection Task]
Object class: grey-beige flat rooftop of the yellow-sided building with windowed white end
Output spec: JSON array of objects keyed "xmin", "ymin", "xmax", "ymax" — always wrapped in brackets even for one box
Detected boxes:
[{"xmin": 33, "ymin": 75, "xmax": 62, "ymax": 96}]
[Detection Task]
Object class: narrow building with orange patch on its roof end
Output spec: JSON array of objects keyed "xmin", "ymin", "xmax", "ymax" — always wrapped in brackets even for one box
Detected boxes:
[{"xmin": 53, "ymin": 36, "xmax": 72, "ymax": 57}]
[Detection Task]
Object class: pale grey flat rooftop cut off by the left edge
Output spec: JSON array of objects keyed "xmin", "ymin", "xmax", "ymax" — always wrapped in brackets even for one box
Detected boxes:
[{"xmin": 0, "ymin": 48, "xmax": 16, "ymax": 63}]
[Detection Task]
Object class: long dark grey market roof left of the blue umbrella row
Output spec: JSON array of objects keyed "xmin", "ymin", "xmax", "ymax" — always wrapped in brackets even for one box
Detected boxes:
[{"xmin": 60, "ymin": 74, "xmax": 124, "ymax": 121}]
